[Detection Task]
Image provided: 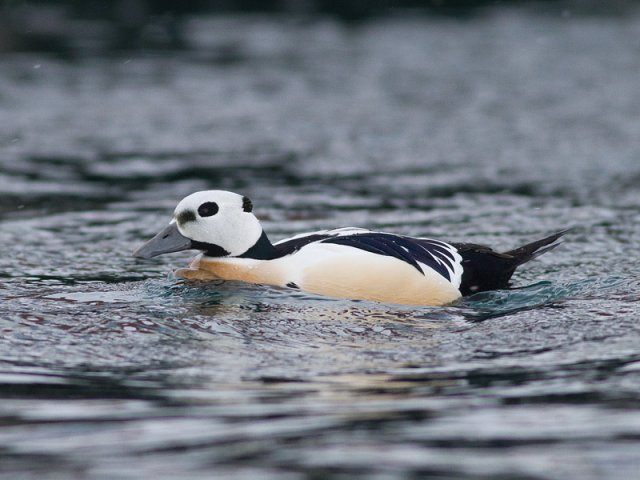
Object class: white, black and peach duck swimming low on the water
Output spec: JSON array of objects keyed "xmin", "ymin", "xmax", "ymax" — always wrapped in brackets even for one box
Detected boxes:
[{"xmin": 133, "ymin": 190, "xmax": 567, "ymax": 306}]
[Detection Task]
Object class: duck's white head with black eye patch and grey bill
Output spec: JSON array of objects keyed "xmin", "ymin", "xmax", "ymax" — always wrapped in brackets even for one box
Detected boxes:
[{"xmin": 133, "ymin": 190, "xmax": 271, "ymax": 258}]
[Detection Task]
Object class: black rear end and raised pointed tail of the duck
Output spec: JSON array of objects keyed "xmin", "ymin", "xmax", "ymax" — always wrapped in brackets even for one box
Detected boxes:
[{"xmin": 452, "ymin": 230, "xmax": 569, "ymax": 295}]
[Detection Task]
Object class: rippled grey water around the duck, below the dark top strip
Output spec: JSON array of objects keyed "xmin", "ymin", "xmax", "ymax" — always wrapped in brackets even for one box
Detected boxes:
[{"xmin": 0, "ymin": 10, "xmax": 640, "ymax": 479}]
